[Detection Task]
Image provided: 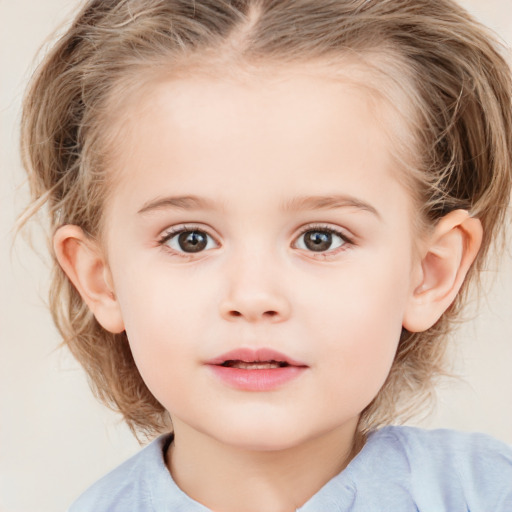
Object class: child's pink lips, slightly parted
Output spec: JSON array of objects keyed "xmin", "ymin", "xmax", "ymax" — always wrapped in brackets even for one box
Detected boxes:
[{"xmin": 206, "ymin": 348, "xmax": 308, "ymax": 391}]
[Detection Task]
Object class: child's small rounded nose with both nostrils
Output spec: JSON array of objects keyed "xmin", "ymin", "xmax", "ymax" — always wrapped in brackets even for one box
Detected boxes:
[{"xmin": 220, "ymin": 255, "xmax": 291, "ymax": 323}]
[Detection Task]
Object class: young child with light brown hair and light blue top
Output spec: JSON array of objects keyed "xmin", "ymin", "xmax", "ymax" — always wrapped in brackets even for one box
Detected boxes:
[{"xmin": 22, "ymin": 0, "xmax": 512, "ymax": 512}]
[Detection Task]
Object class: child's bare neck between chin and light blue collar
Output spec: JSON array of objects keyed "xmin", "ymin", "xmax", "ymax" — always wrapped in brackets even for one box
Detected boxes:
[{"xmin": 166, "ymin": 421, "xmax": 363, "ymax": 512}]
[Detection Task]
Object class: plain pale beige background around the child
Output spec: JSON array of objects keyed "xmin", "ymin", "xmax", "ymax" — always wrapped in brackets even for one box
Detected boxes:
[{"xmin": 0, "ymin": 0, "xmax": 512, "ymax": 512}]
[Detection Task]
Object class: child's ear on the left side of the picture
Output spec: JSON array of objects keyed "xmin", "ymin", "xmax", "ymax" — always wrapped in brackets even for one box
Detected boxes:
[{"xmin": 53, "ymin": 225, "xmax": 124, "ymax": 333}]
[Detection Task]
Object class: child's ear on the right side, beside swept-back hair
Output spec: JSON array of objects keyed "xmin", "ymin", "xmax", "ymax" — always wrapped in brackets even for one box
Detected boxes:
[{"xmin": 403, "ymin": 210, "xmax": 483, "ymax": 332}]
